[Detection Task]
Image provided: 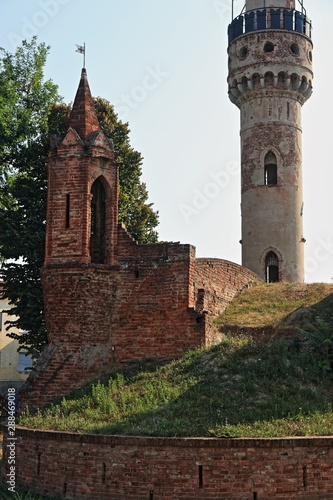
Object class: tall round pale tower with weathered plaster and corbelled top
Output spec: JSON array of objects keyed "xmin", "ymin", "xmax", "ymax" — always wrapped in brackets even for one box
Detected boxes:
[{"xmin": 228, "ymin": 0, "xmax": 313, "ymax": 282}]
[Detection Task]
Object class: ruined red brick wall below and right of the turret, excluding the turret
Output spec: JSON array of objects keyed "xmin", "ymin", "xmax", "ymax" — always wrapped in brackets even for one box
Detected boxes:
[{"xmin": 20, "ymin": 248, "xmax": 258, "ymax": 406}]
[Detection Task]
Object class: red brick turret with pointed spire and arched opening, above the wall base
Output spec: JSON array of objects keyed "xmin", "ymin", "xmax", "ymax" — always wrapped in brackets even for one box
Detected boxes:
[{"xmin": 45, "ymin": 69, "xmax": 118, "ymax": 265}]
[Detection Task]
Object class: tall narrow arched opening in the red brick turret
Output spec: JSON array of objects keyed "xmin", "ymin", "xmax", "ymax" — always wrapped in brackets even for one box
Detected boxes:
[{"xmin": 90, "ymin": 179, "xmax": 106, "ymax": 264}]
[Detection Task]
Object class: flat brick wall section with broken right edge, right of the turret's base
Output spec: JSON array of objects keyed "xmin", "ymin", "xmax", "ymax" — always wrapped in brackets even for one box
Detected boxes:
[{"xmin": 114, "ymin": 238, "xmax": 205, "ymax": 361}]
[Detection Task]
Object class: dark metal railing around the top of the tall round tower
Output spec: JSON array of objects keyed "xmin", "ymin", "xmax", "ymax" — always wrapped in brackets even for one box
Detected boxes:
[{"xmin": 228, "ymin": 9, "xmax": 312, "ymax": 45}]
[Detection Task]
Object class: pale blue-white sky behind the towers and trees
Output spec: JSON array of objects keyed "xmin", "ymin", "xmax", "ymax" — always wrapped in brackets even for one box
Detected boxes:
[{"xmin": 0, "ymin": 0, "xmax": 333, "ymax": 283}]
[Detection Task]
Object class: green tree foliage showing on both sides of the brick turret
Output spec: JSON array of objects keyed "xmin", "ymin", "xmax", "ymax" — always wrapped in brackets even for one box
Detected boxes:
[{"xmin": 0, "ymin": 38, "xmax": 158, "ymax": 356}]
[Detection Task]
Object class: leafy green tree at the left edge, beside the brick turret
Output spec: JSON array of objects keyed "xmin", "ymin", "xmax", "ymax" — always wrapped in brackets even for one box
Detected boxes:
[{"xmin": 0, "ymin": 38, "xmax": 61, "ymax": 355}]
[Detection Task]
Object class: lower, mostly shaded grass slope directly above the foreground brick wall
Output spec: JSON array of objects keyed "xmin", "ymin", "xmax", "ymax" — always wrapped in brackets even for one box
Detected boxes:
[{"xmin": 20, "ymin": 336, "xmax": 333, "ymax": 437}]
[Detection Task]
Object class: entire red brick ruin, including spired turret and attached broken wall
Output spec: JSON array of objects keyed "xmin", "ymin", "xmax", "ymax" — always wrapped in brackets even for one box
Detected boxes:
[{"xmin": 20, "ymin": 70, "xmax": 258, "ymax": 406}]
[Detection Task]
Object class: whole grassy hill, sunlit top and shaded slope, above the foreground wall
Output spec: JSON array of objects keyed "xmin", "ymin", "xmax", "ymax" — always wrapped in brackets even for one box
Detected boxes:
[{"xmin": 20, "ymin": 284, "xmax": 333, "ymax": 437}]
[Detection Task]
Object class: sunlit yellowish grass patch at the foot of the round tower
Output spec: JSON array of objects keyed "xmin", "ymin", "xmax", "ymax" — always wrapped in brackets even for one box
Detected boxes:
[{"xmin": 216, "ymin": 283, "xmax": 333, "ymax": 328}]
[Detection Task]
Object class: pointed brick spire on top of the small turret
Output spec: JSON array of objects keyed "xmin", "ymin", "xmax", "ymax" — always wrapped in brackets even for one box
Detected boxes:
[{"xmin": 68, "ymin": 68, "xmax": 100, "ymax": 141}]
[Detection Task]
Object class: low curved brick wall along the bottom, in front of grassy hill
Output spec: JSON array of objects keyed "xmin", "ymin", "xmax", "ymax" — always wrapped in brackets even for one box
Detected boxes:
[{"xmin": 3, "ymin": 428, "xmax": 333, "ymax": 500}]
